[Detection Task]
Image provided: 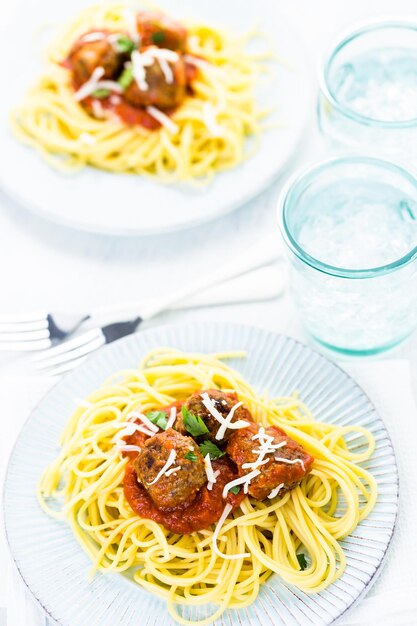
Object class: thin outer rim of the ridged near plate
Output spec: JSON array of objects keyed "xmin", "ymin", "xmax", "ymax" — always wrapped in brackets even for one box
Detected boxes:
[{"xmin": 0, "ymin": 321, "xmax": 400, "ymax": 626}]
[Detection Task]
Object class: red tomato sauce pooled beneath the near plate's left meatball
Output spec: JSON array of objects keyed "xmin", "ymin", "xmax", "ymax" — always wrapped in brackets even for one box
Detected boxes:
[{"xmin": 124, "ymin": 453, "xmax": 245, "ymax": 535}]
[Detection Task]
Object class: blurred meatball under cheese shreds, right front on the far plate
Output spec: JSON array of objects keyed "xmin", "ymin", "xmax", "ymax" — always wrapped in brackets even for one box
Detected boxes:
[{"xmin": 124, "ymin": 48, "xmax": 187, "ymax": 109}]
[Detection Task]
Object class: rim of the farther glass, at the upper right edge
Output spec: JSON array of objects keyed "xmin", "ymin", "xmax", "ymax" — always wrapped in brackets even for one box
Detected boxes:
[{"xmin": 319, "ymin": 17, "xmax": 417, "ymax": 129}]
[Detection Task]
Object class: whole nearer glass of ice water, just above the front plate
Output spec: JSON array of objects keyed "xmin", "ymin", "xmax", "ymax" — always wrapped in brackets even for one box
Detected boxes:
[{"xmin": 279, "ymin": 156, "xmax": 417, "ymax": 355}]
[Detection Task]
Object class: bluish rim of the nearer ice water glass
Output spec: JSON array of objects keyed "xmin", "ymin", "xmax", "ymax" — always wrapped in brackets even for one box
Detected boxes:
[{"xmin": 277, "ymin": 155, "xmax": 417, "ymax": 279}]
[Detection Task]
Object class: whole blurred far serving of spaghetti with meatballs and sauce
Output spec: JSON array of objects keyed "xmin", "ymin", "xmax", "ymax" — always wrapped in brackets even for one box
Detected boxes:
[{"xmin": 12, "ymin": 4, "xmax": 267, "ymax": 182}]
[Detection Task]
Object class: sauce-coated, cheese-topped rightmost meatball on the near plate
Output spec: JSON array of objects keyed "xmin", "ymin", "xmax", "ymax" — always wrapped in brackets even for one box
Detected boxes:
[{"xmin": 227, "ymin": 423, "xmax": 314, "ymax": 500}]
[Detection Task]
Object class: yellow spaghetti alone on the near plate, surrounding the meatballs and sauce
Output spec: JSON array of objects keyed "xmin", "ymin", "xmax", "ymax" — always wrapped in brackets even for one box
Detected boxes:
[{"xmin": 39, "ymin": 348, "xmax": 377, "ymax": 624}]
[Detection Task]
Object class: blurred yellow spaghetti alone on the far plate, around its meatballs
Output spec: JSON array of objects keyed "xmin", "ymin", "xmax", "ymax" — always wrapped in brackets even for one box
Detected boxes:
[{"xmin": 11, "ymin": 4, "xmax": 268, "ymax": 182}]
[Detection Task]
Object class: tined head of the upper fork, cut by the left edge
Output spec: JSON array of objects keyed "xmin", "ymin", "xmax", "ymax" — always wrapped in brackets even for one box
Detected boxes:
[{"xmin": 0, "ymin": 311, "xmax": 90, "ymax": 352}]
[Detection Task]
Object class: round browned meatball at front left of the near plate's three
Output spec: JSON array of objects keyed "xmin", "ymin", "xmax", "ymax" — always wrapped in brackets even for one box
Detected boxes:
[{"xmin": 135, "ymin": 428, "xmax": 207, "ymax": 511}]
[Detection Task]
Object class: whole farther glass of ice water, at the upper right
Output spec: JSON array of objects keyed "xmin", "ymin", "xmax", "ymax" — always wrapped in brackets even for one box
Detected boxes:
[{"xmin": 318, "ymin": 21, "xmax": 417, "ymax": 164}]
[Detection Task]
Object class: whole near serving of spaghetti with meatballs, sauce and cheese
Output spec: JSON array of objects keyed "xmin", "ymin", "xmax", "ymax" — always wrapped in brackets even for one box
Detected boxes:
[{"xmin": 38, "ymin": 348, "xmax": 377, "ymax": 624}]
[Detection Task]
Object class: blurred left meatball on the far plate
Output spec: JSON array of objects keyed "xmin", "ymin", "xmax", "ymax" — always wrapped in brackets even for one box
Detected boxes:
[{"xmin": 68, "ymin": 36, "xmax": 123, "ymax": 85}]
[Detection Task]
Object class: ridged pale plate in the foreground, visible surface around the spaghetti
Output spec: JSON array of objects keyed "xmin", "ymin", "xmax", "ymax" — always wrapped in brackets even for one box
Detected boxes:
[{"xmin": 4, "ymin": 323, "xmax": 398, "ymax": 626}]
